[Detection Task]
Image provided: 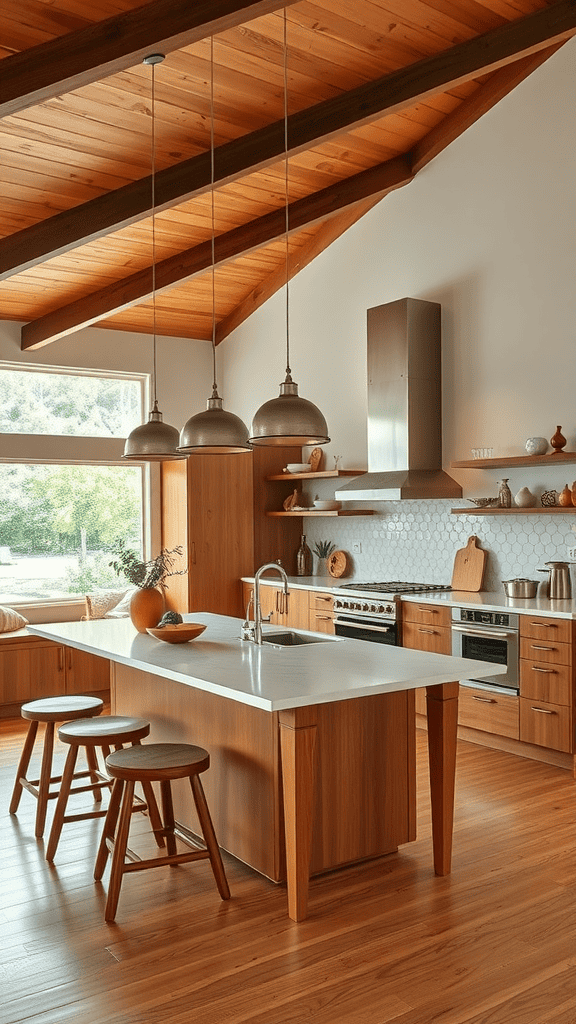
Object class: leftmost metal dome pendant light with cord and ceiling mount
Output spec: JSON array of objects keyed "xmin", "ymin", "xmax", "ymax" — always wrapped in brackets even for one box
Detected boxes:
[{"xmin": 122, "ymin": 53, "xmax": 186, "ymax": 462}]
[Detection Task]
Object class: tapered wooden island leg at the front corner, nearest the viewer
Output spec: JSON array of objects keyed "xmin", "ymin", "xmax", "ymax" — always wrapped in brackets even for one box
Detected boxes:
[{"xmin": 279, "ymin": 707, "xmax": 316, "ymax": 921}]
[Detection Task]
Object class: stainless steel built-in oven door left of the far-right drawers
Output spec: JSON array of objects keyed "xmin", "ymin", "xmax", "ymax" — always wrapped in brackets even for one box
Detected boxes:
[{"xmin": 452, "ymin": 623, "xmax": 520, "ymax": 695}]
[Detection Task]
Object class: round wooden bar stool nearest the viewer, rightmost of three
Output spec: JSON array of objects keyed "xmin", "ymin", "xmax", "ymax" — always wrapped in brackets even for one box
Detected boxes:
[{"xmin": 94, "ymin": 743, "xmax": 230, "ymax": 921}]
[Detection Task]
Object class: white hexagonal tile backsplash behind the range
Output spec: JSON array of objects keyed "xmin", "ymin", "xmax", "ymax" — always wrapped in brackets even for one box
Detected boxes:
[{"xmin": 302, "ymin": 496, "xmax": 576, "ymax": 591}]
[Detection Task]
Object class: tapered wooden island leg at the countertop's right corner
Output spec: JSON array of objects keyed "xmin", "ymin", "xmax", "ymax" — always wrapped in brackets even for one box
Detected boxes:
[{"xmin": 426, "ymin": 683, "xmax": 459, "ymax": 874}]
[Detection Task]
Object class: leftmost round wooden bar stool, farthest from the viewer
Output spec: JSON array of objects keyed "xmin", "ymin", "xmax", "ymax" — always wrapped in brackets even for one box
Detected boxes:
[{"xmin": 10, "ymin": 695, "xmax": 104, "ymax": 839}]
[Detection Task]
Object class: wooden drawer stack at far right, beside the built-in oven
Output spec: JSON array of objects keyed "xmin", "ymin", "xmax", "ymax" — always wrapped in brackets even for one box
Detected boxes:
[{"xmin": 520, "ymin": 615, "xmax": 575, "ymax": 753}]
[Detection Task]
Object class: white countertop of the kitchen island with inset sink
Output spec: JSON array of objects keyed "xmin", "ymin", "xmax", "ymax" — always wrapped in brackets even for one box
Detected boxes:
[{"xmin": 28, "ymin": 612, "xmax": 505, "ymax": 712}]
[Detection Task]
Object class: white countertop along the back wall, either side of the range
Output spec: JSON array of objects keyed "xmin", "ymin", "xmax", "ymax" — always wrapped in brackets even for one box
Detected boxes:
[{"xmin": 243, "ymin": 575, "xmax": 576, "ymax": 618}]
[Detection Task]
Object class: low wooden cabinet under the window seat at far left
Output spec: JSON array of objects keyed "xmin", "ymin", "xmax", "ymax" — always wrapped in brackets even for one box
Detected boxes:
[{"xmin": 0, "ymin": 631, "xmax": 110, "ymax": 715}]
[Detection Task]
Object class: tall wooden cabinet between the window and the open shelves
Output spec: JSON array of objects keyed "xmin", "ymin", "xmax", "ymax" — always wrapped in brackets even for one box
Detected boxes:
[{"xmin": 161, "ymin": 447, "xmax": 301, "ymax": 616}]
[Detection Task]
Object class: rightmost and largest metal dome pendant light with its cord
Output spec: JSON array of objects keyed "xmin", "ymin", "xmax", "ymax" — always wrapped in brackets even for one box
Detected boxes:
[{"xmin": 250, "ymin": 8, "xmax": 330, "ymax": 446}]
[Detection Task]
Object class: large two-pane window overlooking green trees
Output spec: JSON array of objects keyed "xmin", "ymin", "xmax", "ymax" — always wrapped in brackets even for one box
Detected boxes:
[{"xmin": 0, "ymin": 364, "xmax": 143, "ymax": 604}]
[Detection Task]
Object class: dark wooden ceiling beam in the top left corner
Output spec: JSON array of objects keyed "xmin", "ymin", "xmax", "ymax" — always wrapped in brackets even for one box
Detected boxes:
[{"xmin": 0, "ymin": 0, "xmax": 297, "ymax": 117}]
